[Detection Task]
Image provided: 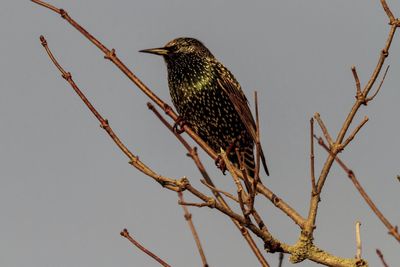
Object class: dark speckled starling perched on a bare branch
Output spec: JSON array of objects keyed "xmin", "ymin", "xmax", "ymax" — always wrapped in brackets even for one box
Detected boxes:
[{"xmin": 140, "ymin": 37, "xmax": 269, "ymax": 177}]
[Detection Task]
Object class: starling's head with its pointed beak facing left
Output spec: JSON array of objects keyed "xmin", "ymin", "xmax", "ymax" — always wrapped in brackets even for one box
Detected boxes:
[{"xmin": 139, "ymin": 37, "xmax": 213, "ymax": 62}]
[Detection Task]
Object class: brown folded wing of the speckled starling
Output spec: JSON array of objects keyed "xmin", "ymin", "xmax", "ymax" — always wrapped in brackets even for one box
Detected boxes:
[{"xmin": 216, "ymin": 62, "xmax": 269, "ymax": 175}]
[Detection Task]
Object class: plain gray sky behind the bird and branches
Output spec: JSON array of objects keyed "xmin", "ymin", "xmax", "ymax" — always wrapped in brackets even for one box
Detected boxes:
[{"xmin": 0, "ymin": 0, "xmax": 400, "ymax": 267}]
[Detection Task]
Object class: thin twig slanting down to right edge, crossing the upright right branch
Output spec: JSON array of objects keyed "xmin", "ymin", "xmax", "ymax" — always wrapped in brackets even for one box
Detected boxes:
[{"xmin": 315, "ymin": 136, "xmax": 400, "ymax": 242}]
